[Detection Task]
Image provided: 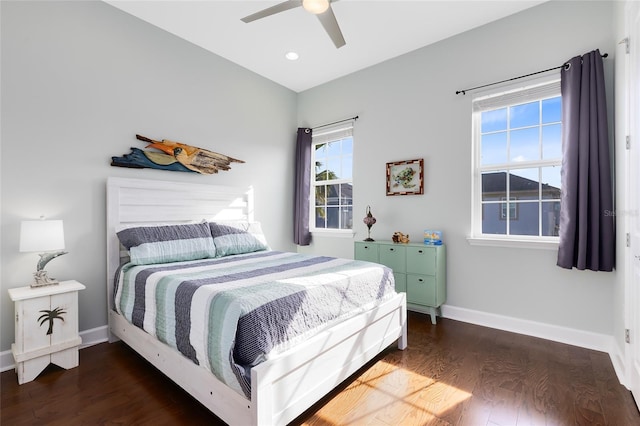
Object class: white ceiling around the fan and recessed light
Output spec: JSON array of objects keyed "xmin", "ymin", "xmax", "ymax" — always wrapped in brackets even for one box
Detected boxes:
[{"xmin": 105, "ymin": 0, "xmax": 547, "ymax": 92}]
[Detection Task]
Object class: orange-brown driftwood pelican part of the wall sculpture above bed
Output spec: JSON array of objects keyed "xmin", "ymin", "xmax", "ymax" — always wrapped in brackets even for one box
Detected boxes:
[{"xmin": 136, "ymin": 135, "xmax": 244, "ymax": 174}]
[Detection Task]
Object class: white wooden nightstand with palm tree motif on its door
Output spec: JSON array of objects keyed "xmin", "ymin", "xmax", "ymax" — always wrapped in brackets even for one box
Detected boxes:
[{"xmin": 9, "ymin": 281, "xmax": 85, "ymax": 384}]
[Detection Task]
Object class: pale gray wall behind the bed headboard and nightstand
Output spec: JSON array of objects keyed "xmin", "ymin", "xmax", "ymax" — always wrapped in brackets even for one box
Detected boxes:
[{"xmin": 0, "ymin": 1, "xmax": 297, "ymax": 351}]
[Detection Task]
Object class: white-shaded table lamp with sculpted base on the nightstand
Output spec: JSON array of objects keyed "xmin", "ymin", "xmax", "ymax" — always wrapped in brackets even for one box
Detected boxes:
[{"xmin": 20, "ymin": 219, "xmax": 67, "ymax": 287}]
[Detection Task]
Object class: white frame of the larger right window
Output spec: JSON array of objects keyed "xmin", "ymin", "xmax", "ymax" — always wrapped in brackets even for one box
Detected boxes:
[{"xmin": 467, "ymin": 74, "xmax": 560, "ymax": 250}]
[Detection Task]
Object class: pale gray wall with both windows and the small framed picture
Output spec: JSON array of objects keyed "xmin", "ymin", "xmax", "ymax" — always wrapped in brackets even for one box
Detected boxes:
[{"xmin": 298, "ymin": 2, "xmax": 621, "ymax": 335}]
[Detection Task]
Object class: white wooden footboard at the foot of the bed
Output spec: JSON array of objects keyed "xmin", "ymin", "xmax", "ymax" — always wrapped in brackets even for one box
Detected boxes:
[{"xmin": 251, "ymin": 293, "xmax": 407, "ymax": 425}]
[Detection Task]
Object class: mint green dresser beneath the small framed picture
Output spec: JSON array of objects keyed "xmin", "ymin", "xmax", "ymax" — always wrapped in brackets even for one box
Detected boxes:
[{"xmin": 355, "ymin": 241, "xmax": 447, "ymax": 324}]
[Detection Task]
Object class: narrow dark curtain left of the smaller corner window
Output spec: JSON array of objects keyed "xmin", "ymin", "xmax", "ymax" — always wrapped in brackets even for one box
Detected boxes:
[{"xmin": 293, "ymin": 128, "xmax": 312, "ymax": 246}]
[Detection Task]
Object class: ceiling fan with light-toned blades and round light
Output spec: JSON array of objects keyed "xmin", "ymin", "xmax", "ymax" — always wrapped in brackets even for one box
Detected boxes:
[{"xmin": 241, "ymin": 0, "xmax": 346, "ymax": 48}]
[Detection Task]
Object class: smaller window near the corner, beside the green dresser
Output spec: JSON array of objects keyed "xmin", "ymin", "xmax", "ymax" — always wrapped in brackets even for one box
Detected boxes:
[{"xmin": 309, "ymin": 122, "xmax": 353, "ymax": 232}]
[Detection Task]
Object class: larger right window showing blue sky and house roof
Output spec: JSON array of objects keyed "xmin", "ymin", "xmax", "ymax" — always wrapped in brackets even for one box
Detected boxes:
[{"xmin": 471, "ymin": 77, "xmax": 562, "ymax": 242}]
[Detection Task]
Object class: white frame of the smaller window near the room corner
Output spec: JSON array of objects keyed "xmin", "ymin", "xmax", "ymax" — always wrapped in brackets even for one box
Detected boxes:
[{"xmin": 309, "ymin": 120, "xmax": 355, "ymax": 237}]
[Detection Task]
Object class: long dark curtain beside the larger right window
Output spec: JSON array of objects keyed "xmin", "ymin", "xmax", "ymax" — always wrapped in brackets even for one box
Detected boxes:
[{"xmin": 557, "ymin": 50, "xmax": 615, "ymax": 271}]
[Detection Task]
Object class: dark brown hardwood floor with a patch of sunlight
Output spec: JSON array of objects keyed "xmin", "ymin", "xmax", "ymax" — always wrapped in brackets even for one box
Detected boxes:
[{"xmin": 0, "ymin": 313, "xmax": 640, "ymax": 426}]
